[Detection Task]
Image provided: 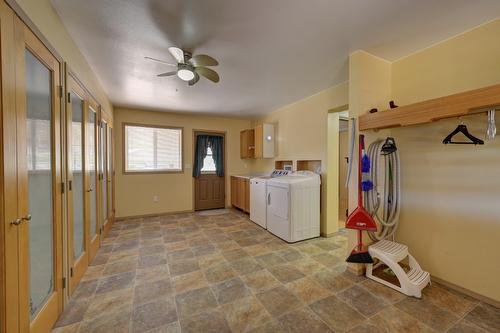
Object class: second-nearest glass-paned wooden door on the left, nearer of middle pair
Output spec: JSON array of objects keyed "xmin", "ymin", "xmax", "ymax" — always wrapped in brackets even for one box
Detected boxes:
[{"xmin": 66, "ymin": 75, "xmax": 89, "ymax": 294}]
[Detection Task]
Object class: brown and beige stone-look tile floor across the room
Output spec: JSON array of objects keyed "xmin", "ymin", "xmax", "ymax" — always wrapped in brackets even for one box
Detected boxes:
[{"xmin": 53, "ymin": 211, "xmax": 500, "ymax": 333}]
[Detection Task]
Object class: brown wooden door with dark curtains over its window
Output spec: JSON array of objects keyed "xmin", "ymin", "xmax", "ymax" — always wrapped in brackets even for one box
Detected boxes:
[{"xmin": 193, "ymin": 130, "xmax": 226, "ymax": 211}]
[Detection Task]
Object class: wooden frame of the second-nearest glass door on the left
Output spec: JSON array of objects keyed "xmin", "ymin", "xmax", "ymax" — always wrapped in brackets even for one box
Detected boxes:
[{"xmin": 65, "ymin": 70, "xmax": 90, "ymax": 296}]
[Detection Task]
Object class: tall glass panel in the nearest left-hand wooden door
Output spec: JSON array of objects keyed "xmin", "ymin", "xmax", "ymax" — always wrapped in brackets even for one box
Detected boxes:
[{"xmin": 25, "ymin": 50, "xmax": 55, "ymax": 319}]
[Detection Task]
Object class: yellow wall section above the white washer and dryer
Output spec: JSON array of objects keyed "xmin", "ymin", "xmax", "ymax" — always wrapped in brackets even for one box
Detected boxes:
[{"xmin": 252, "ymin": 83, "xmax": 348, "ymax": 235}]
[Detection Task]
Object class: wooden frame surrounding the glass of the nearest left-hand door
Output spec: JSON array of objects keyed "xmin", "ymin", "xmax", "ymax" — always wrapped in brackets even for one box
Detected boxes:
[{"xmin": 14, "ymin": 16, "xmax": 63, "ymax": 332}]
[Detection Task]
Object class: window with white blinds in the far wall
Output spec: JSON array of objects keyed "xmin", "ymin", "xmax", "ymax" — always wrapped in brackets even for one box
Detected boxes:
[{"xmin": 124, "ymin": 125, "xmax": 182, "ymax": 172}]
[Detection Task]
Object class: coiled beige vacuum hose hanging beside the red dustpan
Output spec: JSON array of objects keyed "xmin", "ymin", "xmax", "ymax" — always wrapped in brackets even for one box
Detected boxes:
[{"xmin": 364, "ymin": 138, "xmax": 401, "ymax": 241}]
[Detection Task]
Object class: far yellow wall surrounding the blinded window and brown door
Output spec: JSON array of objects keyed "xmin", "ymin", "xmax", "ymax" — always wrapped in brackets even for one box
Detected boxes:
[{"xmin": 114, "ymin": 108, "xmax": 251, "ymax": 217}]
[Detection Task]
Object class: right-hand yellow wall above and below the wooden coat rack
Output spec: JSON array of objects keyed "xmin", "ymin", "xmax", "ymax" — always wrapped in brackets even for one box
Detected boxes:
[{"xmin": 391, "ymin": 20, "xmax": 500, "ymax": 301}]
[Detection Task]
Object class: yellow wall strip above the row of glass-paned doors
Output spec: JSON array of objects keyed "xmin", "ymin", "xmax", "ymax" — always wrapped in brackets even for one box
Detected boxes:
[{"xmin": 11, "ymin": 0, "xmax": 113, "ymax": 115}]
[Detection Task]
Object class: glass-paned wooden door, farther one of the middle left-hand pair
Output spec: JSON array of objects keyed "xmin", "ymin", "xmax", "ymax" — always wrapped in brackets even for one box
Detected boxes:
[{"xmin": 85, "ymin": 99, "xmax": 101, "ymax": 262}]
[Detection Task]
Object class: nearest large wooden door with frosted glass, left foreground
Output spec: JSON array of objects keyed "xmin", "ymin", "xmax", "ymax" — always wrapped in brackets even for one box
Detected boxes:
[{"xmin": 14, "ymin": 17, "xmax": 63, "ymax": 332}]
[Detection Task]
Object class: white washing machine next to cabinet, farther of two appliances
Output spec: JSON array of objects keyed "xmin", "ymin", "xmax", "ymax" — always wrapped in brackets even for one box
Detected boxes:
[{"xmin": 250, "ymin": 170, "xmax": 290, "ymax": 229}]
